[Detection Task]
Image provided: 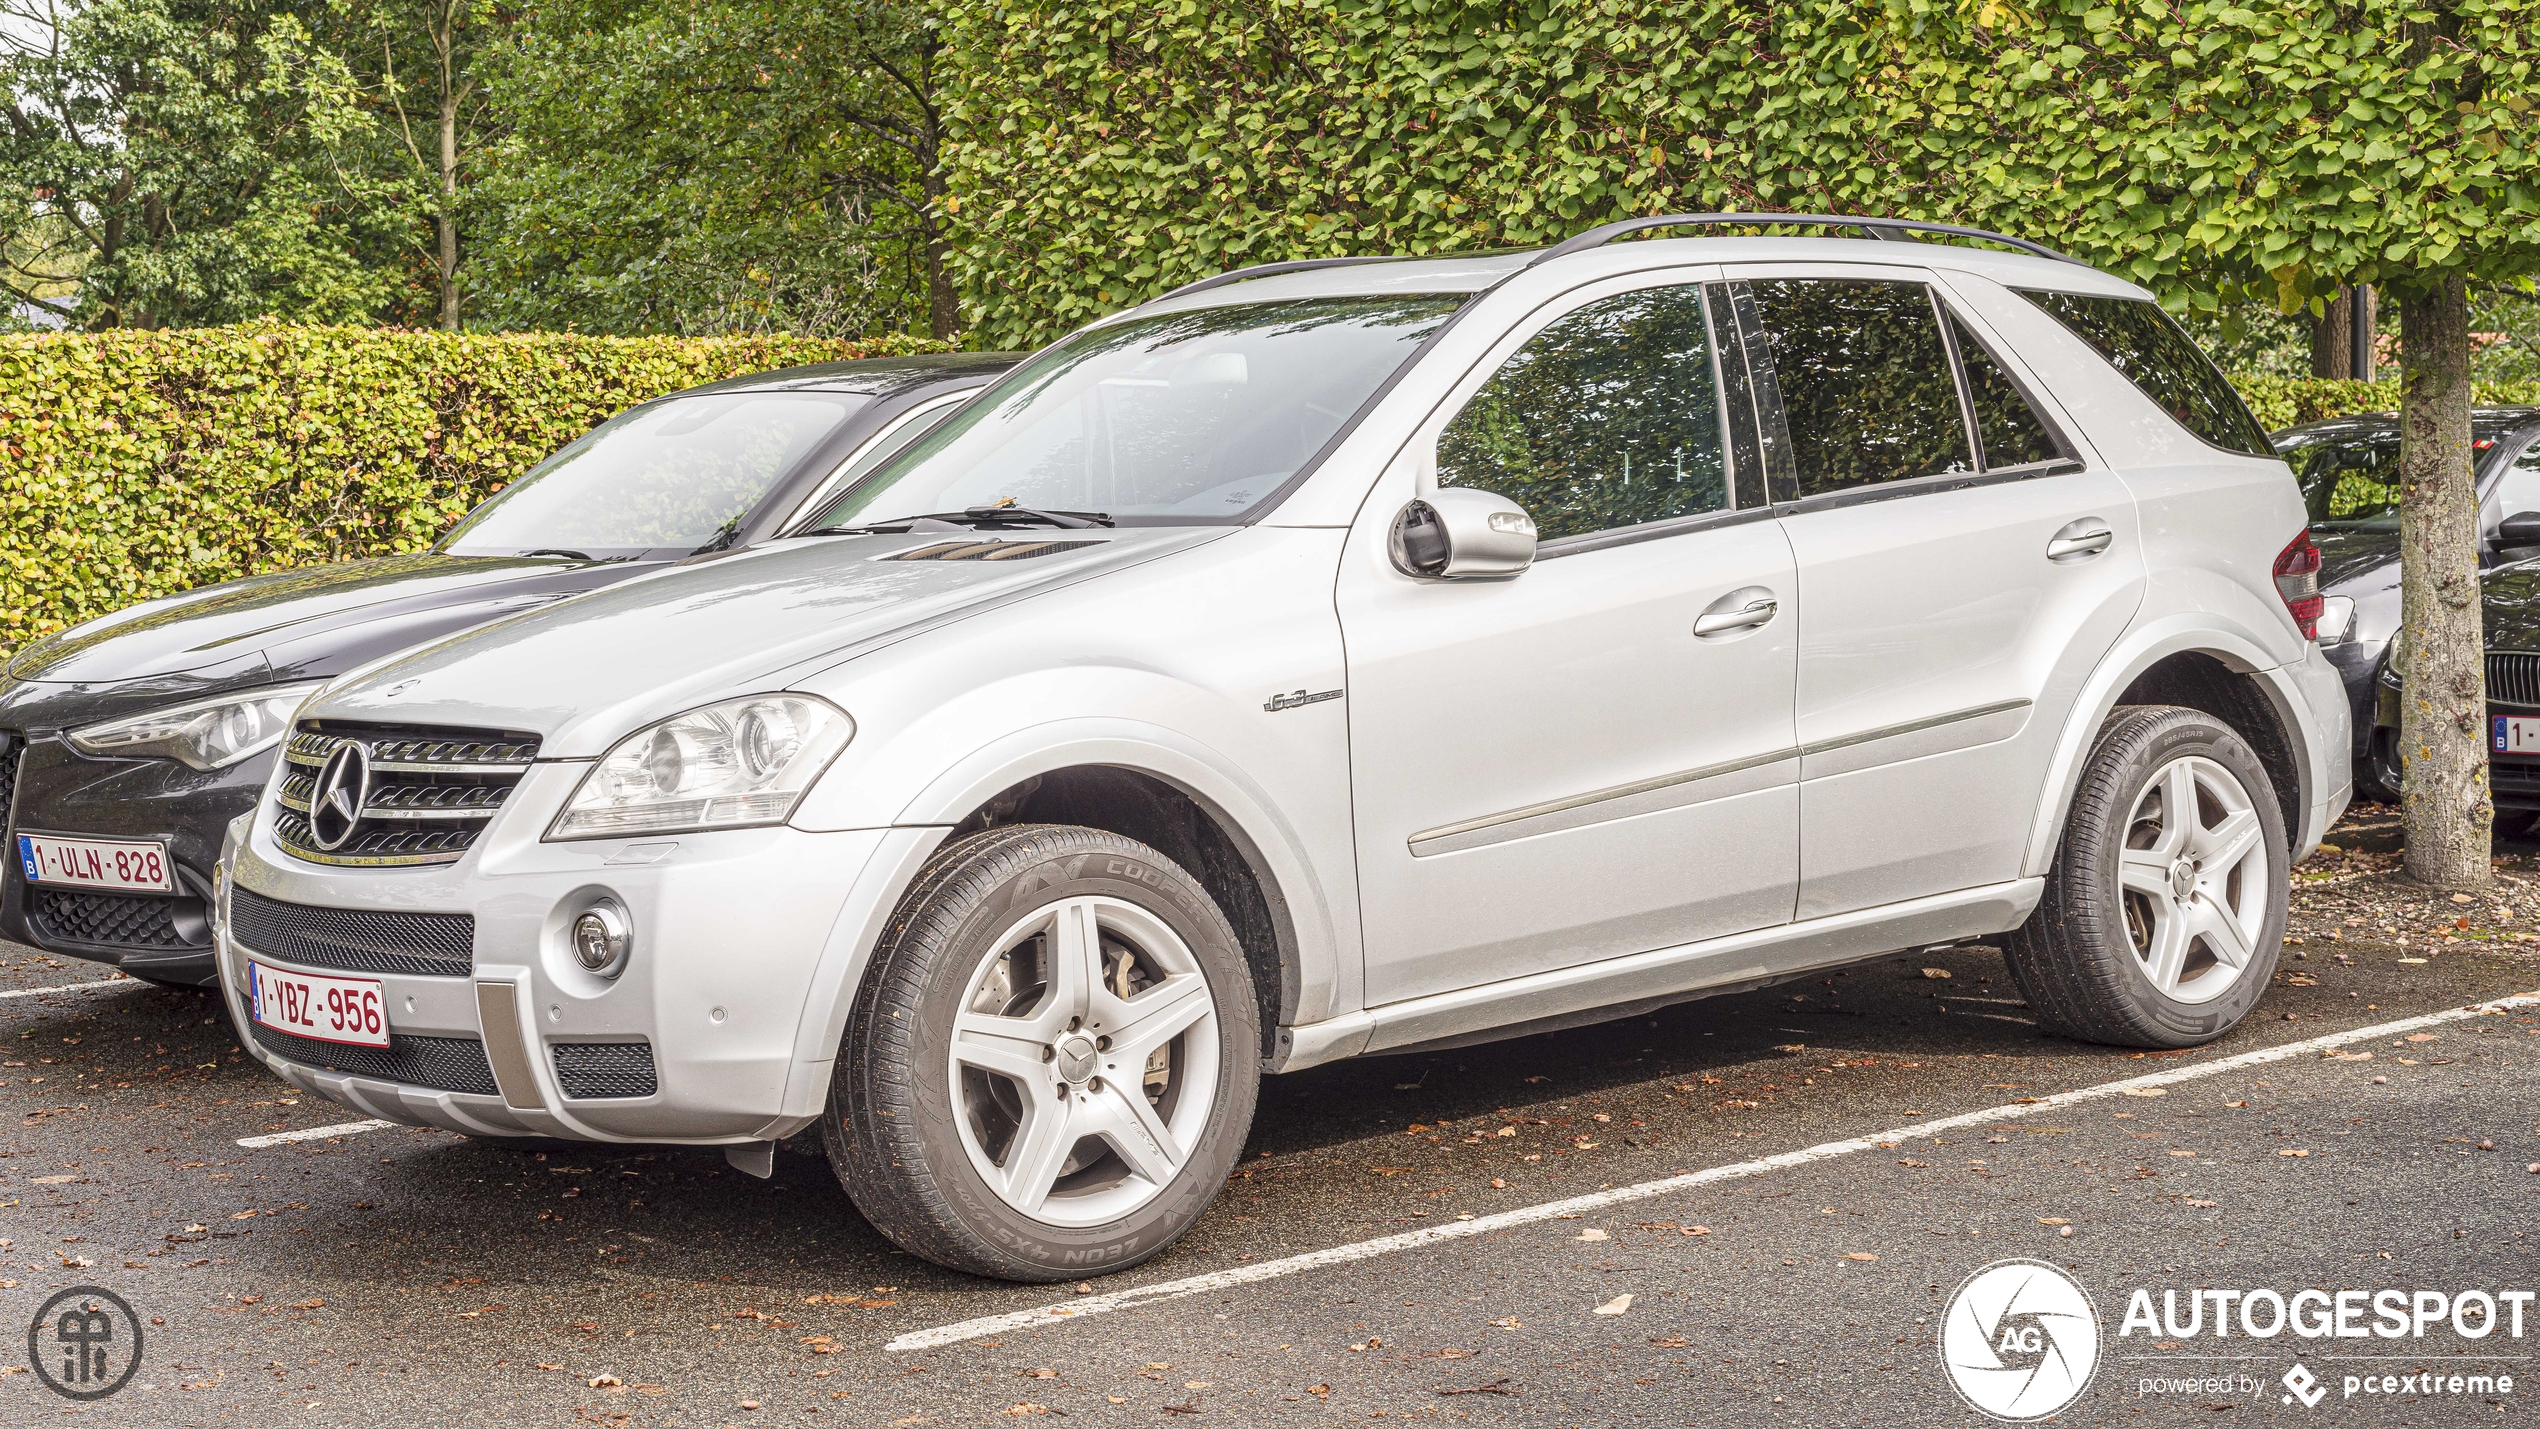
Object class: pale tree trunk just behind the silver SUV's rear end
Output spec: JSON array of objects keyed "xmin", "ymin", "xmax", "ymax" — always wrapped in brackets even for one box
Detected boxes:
[{"xmin": 2398, "ymin": 277, "xmax": 2497, "ymax": 888}]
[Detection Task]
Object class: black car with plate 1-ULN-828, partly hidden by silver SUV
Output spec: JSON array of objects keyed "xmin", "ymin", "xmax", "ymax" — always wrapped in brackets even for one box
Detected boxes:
[{"xmin": 0, "ymin": 353, "xmax": 1013, "ymax": 985}]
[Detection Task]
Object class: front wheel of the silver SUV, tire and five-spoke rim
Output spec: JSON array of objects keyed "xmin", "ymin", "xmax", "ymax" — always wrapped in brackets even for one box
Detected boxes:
[{"xmin": 820, "ymin": 825, "xmax": 1260, "ymax": 1282}]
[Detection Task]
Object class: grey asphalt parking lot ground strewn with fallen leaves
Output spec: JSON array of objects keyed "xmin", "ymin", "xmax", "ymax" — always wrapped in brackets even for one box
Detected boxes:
[{"xmin": 0, "ymin": 812, "xmax": 2540, "ymax": 1429}]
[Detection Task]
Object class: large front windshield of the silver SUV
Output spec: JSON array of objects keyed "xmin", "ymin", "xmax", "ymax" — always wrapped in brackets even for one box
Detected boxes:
[{"xmin": 810, "ymin": 294, "xmax": 1463, "ymax": 528}]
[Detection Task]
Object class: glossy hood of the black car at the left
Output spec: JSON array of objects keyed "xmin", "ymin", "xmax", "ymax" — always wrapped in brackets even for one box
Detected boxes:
[{"xmin": 8, "ymin": 553, "xmax": 640, "ymax": 688}]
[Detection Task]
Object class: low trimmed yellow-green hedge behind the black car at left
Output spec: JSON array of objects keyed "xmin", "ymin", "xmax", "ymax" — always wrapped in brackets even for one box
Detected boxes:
[{"xmin": 0, "ymin": 325, "xmax": 942, "ymax": 650}]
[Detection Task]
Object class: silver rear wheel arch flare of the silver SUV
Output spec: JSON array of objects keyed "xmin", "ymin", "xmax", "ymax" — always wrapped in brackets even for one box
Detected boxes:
[{"xmin": 2022, "ymin": 619, "xmax": 2314, "ymax": 878}]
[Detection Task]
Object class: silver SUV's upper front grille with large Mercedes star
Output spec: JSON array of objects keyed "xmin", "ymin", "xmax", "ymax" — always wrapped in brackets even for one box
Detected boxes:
[{"xmin": 274, "ymin": 721, "xmax": 538, "ymax": 868}]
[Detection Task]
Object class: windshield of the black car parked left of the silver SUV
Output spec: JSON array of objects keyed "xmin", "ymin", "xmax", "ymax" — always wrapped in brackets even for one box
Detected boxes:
[{"xmin": 442, "ymin": 391, "xmax": 866, "ymax": 558}]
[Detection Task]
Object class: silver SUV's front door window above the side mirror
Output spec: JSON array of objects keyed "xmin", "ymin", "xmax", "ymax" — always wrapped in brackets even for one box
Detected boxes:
[{"xmin": 1438, "ymin": 287, "xmax": 1730, "ymax": 541}]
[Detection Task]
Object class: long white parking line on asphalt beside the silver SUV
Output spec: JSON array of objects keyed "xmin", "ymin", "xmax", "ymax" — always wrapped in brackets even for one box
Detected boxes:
[{"xmin": 884, "ymin": 992, "xmax": 2540, "ymax": 1353}]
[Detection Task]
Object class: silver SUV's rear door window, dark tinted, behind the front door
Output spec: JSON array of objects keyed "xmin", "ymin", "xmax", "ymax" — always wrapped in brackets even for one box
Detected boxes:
[{"xmin": 1748, "ymin": 279, "xmax": 1974, "ymax": 497}]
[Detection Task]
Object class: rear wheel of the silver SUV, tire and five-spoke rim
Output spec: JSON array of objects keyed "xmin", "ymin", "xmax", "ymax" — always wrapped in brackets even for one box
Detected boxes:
[{"xmin": 2004, "ymin": 706, "xmax": 2289, "ymax": 1048}]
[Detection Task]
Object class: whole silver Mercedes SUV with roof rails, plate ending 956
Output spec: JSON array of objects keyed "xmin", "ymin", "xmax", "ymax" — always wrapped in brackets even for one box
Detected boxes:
[{"xmin": 218, "ymin": 218, "xmax": 2350, "ymax": 1279}]
